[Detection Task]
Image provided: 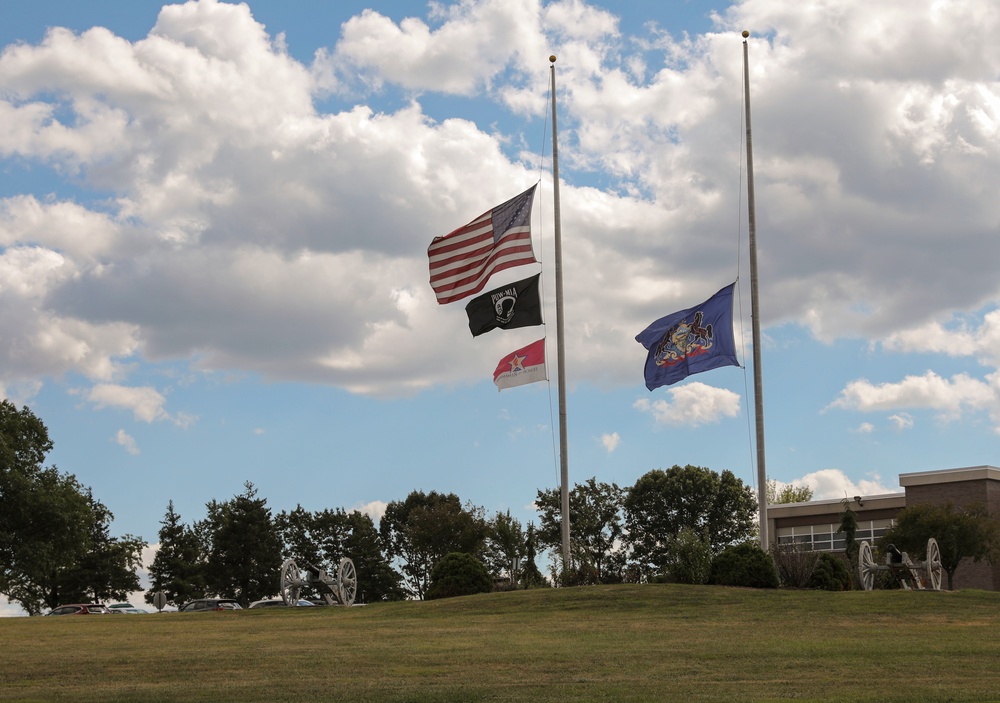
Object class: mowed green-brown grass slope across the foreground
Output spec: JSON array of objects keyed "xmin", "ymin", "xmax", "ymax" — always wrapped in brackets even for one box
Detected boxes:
[{"xmin": 0, "ymin": 585, "xmax": 1000, "ymax": 703}]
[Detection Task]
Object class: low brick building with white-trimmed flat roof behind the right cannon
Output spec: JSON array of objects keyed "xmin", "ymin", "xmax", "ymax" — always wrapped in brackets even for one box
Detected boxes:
[{"xmin": 767, "ymin": 466, "xmax": 1000, "ymax": 590}]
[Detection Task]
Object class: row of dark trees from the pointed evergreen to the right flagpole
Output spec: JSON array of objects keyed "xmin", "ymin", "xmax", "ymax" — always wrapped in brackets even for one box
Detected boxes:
[{"xmin": 147, "ymin": 466, "xmax": 757, "ymax": 604}]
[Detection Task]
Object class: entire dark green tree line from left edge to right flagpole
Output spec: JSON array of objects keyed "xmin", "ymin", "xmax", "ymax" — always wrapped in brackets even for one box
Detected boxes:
[{"xmin": 0, "ymin": 401, "xmax": 756, "ymax": 614}]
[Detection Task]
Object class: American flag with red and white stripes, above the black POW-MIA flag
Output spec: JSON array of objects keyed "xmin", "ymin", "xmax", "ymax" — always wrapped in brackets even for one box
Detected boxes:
[{"xmin": 427, "ymin": 186, "xmax": 537, "ymax": 305}]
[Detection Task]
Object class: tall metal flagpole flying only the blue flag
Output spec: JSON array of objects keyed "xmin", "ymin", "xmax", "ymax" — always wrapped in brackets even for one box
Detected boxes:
[{"xmin": 743, "ymin": 30, "xmax": 770, "ymax": 552}]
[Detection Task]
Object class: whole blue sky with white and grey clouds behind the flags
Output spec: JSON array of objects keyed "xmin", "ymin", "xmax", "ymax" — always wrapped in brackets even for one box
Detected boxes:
[{"xmin": 0, "ymin": 0, "xmax": 1000, "ymax": 612}]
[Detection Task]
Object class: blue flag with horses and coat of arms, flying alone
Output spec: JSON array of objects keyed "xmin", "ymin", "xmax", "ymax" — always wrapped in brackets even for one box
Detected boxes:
[{"xmin": 635, "ymin": 283, "xmax": 740, "ymax": 390}]
